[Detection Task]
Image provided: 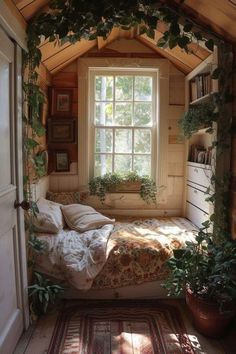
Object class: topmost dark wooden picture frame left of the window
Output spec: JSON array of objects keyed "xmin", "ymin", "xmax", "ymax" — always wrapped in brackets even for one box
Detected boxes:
[{"xmin": 51, "ymin": 88, "xmax": 73, "ymax": 117}]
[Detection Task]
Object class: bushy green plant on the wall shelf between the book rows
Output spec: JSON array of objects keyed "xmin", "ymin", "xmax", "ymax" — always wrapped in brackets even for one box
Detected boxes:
[{"xmin": 179, "ymin": 100, "xmax": 218, "ymax": 138}]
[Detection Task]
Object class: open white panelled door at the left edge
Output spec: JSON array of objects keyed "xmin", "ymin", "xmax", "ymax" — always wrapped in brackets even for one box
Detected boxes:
[{"xmin": 0, "ymin": 29, "xmax": 24, "ymax": 354}]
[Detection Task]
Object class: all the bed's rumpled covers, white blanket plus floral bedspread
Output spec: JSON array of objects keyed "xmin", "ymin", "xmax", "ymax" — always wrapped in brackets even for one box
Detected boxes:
[{"xmin": 36, "ymin": 217, "xmax": 196, "ymax": 290}]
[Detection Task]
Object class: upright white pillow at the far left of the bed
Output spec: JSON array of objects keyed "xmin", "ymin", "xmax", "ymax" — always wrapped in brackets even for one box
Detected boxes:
[{"xmin": 34, "ymin": 198, "xmax": 65, "ymax": 234}]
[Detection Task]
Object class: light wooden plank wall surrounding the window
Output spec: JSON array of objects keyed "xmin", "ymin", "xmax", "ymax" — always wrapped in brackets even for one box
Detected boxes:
[{"xmin": 50, "ymin": 56, "xmax": 185, "ymax": 215}]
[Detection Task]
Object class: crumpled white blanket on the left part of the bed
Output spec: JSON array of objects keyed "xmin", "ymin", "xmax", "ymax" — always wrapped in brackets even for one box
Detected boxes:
[{"xmin": 36, "ymin": 225, "xmax": 113, "ymax": 290}]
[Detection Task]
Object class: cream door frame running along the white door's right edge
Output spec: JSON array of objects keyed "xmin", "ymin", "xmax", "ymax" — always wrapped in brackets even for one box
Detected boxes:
[{"xmin": 0, "ymin": 18, "xmax": 30, "ymax": 330}]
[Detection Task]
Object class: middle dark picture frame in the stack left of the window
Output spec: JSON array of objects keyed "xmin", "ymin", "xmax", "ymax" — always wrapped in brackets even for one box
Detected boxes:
[{"xmin": 48, "ymin": 118, "xmax": 76, "ymax": 144}]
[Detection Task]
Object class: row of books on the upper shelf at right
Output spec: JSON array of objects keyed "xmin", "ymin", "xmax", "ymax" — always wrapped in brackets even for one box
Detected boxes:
[{"xmin": 190, "ymin": 72, "xmax": 211, "ymax": 101}]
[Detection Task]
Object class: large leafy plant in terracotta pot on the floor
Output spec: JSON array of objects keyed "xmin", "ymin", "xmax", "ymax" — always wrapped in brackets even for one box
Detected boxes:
[{"xmin": 164, "ymin": 222, "xmax": 236, "ymax": 337}]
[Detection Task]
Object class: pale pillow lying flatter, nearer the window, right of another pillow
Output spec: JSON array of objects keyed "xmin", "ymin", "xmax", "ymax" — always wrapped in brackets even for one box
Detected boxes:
[{"xmin": 61, "ymin": 204, "xmax": 115, "ymax": 232}]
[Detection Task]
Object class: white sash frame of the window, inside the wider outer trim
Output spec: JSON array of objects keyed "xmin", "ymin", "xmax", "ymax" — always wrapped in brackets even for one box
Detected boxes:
[{"xmin": 88, "ymin": 67, "xmax": 159, "ymax": 180}]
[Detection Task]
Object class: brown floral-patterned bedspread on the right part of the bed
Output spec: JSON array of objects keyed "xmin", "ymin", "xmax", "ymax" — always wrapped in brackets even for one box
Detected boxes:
[{"xmin": 92, "ymin": 218, "xmax": 196, "ymax": 289}]
